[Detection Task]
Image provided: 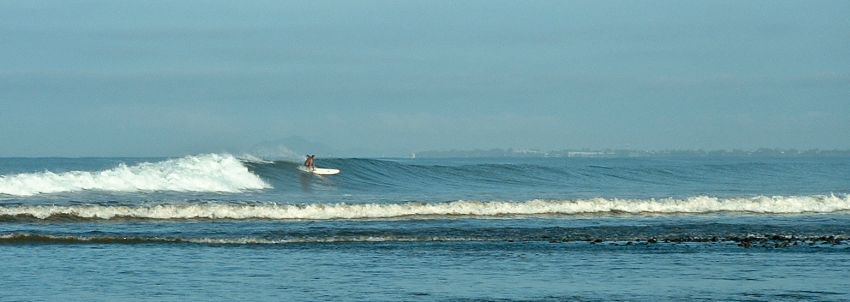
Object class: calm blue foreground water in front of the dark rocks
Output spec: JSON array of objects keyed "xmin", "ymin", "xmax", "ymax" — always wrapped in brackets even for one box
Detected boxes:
[{"xmin": 0, "ymin": 242, "xmax": 850, "ymax": 301}]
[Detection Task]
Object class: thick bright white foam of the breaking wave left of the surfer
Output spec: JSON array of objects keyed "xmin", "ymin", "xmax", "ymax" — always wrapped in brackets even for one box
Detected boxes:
[{"xmin": 0, "ymin": 154, "xmax": 270, "ymax": 196}]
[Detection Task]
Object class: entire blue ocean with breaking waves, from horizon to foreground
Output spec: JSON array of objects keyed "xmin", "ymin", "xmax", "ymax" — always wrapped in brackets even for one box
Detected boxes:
[{"xmin": 0, "ymin": 154, "xmax": 850, "ymax": 301}]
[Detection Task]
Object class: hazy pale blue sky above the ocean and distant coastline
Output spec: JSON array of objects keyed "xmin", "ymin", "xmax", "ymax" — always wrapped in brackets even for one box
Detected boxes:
[{"xmin": 0, "ymin": 0, "xmax": 850, "ymax": 156}]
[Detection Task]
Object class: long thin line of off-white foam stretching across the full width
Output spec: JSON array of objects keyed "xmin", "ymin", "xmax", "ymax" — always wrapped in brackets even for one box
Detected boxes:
[{"xmin": 0, "ymin": 195, "xmax": 850, "ymax": 219}]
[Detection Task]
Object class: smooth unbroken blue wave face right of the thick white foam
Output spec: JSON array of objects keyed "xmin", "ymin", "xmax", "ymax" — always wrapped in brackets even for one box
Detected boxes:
[{"xmin": 246, "ymin": 158, "xmax": 850, "ymax": 201}]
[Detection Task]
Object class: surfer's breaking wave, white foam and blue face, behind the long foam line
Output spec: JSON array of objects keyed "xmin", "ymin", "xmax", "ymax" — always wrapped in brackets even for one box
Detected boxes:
[{"xmin": 0, "ymin": 154, "xmax": 850, "ymax": 199}]
